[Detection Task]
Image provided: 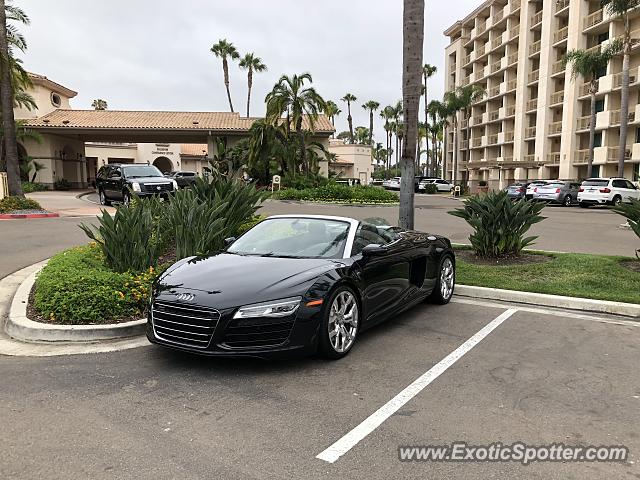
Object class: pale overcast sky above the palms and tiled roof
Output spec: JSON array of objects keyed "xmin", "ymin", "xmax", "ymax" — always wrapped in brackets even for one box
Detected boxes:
[{"xmin": 20, "ymin": 0, "xmax": 482, "ymax": 142}]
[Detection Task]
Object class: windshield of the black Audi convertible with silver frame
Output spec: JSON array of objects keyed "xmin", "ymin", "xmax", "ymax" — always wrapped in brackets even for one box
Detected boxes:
[{"xmin": 227, "ymin": 218, "xmax": 351, "ymax": 258}]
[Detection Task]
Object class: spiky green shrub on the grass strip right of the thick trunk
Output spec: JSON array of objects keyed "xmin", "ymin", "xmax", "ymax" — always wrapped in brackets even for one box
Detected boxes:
[{"xmin": 449, "ymin": 192, "xmax": 545, "ymax": 258}]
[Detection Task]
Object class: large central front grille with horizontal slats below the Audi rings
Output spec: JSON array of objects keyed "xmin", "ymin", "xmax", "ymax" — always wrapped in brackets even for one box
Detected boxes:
[{"xmin": 151, "ymin": 302, "xmax": 220, "ymax": 348}]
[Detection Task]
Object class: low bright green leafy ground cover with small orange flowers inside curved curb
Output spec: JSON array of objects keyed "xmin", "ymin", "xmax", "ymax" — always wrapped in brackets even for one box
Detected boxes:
[{"xmin": 33, "ymin": 244, "xmax": 158, "ymax": 324}]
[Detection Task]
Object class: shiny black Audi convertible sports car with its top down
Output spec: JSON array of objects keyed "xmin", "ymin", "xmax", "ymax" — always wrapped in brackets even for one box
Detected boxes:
[{"xmin": 147, "ymin": 215, "xmax": 455, "ymax": 359}]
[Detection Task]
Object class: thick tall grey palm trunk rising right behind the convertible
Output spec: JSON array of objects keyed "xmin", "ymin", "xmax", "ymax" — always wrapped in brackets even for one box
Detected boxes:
[{"xmin": 398, "ymin": 0, "xmax": 424, "ymax": 229}]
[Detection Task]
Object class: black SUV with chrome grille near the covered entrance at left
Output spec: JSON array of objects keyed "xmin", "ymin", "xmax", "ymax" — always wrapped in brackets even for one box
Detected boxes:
[{"xmin": 96, "ymin": 163, "xmax": 178, "ymax": 205}]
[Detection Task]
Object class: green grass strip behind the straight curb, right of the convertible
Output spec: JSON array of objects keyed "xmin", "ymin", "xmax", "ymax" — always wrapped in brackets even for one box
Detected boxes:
[{"xmin": 456, "ymin": 253, "xmax": 640, "ymax": 303}]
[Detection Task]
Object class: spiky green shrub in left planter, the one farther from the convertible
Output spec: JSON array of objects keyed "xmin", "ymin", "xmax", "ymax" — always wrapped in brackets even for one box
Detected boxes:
[{"xmin": 80, "ymin": 198, "xmax": 163, "ymax": 272}]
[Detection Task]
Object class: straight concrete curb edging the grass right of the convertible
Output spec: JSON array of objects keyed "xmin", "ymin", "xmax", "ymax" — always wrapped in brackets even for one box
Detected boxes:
[{"xmin": 455, "ymin": 284, "xmax": 640, "ymax": 318}]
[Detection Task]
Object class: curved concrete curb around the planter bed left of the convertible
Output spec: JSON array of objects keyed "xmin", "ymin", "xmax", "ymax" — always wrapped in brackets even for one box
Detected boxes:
[{"xmin": 5, "ymin": 261, "xmax": 147, "ymax": 343}]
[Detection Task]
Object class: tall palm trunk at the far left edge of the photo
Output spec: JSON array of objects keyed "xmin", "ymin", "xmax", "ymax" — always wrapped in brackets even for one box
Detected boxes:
[{"xmin": 0, "ymin": 0, "xmax": 24, "ymax": 197}]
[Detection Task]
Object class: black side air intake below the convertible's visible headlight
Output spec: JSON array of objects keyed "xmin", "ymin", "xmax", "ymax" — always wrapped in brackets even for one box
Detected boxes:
[{"xmin": 222, "ymin": 317, "xmax": 294, "ymax": 348}]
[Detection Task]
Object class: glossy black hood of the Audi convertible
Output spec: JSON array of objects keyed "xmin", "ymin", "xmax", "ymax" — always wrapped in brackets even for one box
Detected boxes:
[{"xmin": 155, "ymin": 253, "xmax": 343, "ymax": 309}]
